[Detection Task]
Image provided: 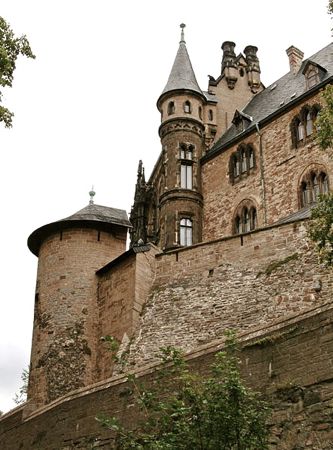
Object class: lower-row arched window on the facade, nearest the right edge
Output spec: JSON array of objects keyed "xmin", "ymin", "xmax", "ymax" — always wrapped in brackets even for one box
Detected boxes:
[{"xmin": 300, "ymin": 169, "xmax": 329, "ymax": 208}]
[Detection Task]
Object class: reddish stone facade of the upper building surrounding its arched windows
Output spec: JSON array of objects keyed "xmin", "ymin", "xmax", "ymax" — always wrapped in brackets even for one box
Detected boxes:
[{"xmin": 202, "ymin": 90, "xmax": 333, "ymax": 241}]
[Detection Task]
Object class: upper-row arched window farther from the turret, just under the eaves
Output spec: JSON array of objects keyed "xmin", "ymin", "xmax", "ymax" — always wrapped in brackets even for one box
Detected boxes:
[{"xmin": 290, "ymin": 104, "xmax": 320, "ymax": 148}]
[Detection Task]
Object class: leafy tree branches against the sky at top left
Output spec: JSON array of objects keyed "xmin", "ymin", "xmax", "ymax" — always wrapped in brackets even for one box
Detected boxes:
[{"xmin": 0, "ymin": 17, "xmax": 35, "ymax": 127}]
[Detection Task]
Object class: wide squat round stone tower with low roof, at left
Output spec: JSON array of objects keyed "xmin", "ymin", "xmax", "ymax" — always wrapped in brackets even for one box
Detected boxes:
[{"xmin": 28, "ymin": 199, "xmax": 130, "ymax": 409}]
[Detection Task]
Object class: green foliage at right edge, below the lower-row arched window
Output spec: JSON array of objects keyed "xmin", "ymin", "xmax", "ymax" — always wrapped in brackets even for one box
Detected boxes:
[{"xmin": 308, "ymin": 193, "xmax": 333, "ymax": 266}]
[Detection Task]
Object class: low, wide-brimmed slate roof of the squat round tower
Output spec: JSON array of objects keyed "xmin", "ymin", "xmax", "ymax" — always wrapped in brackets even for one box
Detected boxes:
[{"xmin": 28, "ymin": 204, "xmax": 132, "ymax": 256}]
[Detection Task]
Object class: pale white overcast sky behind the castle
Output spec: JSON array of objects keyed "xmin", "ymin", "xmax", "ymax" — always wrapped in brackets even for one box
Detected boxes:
[{"xmin": 0, "ymin": 0, "xmax": 332, "ymax": 411}]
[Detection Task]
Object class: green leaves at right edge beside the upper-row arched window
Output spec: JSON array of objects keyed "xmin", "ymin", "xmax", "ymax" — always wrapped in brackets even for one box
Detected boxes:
[{"xmin": 316, "ymin": 85, "xmax": 333, "ymax": 150}]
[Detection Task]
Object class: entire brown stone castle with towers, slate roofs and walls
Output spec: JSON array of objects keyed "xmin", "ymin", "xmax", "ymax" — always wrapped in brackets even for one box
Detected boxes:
[{"xmin": 0, "ymin": 24, "xmax": 333, "ymax": 449}]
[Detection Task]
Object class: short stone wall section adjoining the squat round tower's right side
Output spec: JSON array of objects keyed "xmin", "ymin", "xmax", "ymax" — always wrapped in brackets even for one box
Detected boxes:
[{"xmin": 96, "ymin": 245, "xmax": 157, "ymax": 380}]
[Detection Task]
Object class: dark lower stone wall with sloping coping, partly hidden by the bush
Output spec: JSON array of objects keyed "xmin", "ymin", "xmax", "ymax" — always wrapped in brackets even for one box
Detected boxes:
[{"xmin": 0, "ymin": 305, "xmax": 333, "ymax": 450}]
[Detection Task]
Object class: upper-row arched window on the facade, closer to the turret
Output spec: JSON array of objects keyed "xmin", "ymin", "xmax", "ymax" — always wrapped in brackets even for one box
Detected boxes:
[{"xmin": 229, "ymin": 144, "xmax": 255, "ymax": 184}]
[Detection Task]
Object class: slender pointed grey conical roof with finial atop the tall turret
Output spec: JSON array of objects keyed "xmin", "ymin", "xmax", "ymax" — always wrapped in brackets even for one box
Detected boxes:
[{"xmin": 160, "ymin": 24, "xmax": 203, "ymax": 103}]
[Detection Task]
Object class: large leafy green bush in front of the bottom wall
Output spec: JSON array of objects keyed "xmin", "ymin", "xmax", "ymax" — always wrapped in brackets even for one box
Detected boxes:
[{"xmin": 97, "ymin": 333, "xmax": 269, "ymax": 450}]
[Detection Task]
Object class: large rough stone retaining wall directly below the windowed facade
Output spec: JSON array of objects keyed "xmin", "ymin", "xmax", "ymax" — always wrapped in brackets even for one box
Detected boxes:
[{"xmin": 124, "ymin": 222, "xmax": 333, "ymax": 366}]
